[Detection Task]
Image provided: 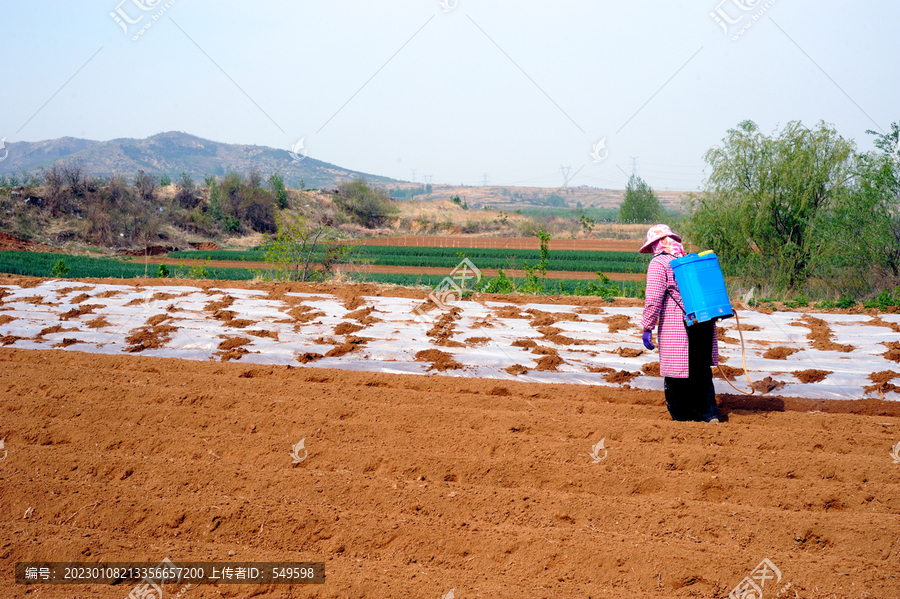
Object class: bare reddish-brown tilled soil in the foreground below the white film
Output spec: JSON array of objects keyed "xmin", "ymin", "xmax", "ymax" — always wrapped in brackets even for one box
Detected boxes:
[{"xmin": 0, "ymin": 349, "xmax": 900, "ymax": 599}]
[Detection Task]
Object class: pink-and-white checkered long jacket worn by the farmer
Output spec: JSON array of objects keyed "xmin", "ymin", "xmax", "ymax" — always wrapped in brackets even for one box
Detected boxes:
[{"xmin": 641, "ymin": 254, "xmax": 719, "ymax": 379}]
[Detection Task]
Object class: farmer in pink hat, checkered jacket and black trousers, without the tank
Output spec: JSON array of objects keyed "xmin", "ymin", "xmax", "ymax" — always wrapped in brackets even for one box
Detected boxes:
[{"xmin": 639, "ymin": 225, "xmax": 719, "ymax": 422}]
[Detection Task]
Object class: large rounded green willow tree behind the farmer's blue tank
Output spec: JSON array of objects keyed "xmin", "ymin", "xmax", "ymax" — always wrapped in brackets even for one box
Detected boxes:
[{"xmin": 683, "ymin": 121, "xmax": 858, "ymax": 288}]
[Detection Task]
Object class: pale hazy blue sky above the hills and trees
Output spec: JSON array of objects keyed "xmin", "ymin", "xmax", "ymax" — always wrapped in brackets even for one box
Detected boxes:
[{"xmin": 0, "ymin": 0, "xmax": 900, "ymax": 189}]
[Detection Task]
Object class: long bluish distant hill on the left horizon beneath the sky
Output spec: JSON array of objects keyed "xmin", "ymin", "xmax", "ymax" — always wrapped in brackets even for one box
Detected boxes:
[{"xmin": 0, "ymin": 131, "xmax": 394, "ymax": 188}]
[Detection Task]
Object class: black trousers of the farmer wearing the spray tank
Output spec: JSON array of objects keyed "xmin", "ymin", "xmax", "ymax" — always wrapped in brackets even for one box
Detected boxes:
[{"xmin": 664, "ymin": 321, "xmax": 719, "ymax": 422}]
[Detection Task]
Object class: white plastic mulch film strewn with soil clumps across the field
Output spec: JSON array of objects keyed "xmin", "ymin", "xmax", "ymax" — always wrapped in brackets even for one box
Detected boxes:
[{"xmin": 0, "ymin": 281, "xmax": 900, "ymax": 401}]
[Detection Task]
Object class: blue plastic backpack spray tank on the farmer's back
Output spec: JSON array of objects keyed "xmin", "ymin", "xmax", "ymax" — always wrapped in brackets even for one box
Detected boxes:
[{"xmin": 671, "ymin": 250, "xmax": 734, "ymax": 326}]
